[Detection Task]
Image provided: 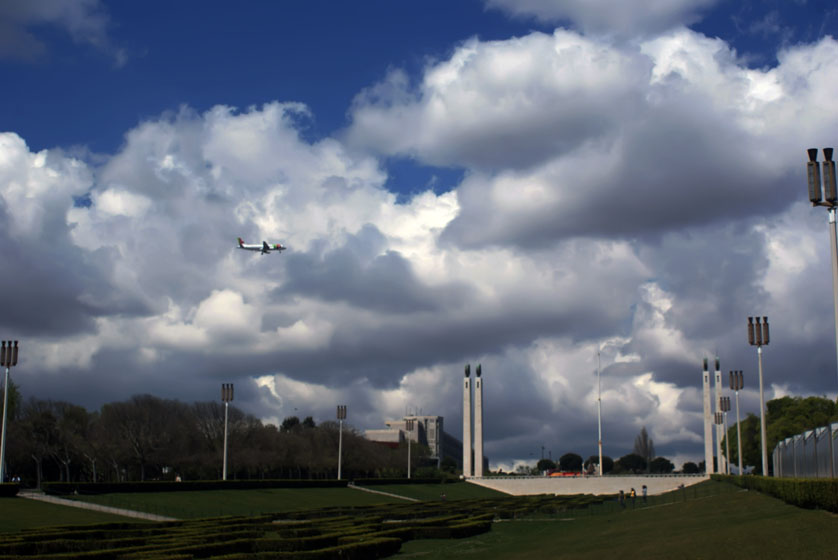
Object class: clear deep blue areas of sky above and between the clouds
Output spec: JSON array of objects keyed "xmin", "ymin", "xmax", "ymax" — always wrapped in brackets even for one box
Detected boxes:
[{"xmin": 0, "ymin": 0, "xmax": 838, "ymax": 193}]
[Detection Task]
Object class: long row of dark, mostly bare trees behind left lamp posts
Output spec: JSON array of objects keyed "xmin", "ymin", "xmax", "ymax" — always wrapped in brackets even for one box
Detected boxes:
[{"xmin": 0, "ymin": 386, "xmax": 429, "ymax": 486}]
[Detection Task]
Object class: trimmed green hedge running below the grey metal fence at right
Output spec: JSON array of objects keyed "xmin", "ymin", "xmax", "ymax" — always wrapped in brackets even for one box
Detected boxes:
[{"xmin": 711, "ymin": 474, "xmax": 838, "ymax": 513}]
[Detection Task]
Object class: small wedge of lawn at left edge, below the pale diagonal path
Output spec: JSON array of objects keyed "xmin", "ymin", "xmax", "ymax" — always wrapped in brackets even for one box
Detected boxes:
[{"xmin": 0, "ymin": 498, "xmax": 142, "ymax": 533}]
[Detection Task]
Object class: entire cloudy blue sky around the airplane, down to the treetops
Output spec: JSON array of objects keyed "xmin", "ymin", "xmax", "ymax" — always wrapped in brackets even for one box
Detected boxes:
[{"xmin": 0, "ymin": 0, "xmax": 838, "ymax": 470}]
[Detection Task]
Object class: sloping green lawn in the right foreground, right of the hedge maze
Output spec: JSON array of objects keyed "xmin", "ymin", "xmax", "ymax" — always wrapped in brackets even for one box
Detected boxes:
[{"xmin": 398, "ymin": 483, "xmax": 838, "ymax": 560}]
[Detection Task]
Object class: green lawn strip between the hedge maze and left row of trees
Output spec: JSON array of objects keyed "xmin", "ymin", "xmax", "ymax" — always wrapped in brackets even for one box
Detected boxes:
[{"xmin": 72, "ymin": 488, "xmax": 402, "ymax": 519}]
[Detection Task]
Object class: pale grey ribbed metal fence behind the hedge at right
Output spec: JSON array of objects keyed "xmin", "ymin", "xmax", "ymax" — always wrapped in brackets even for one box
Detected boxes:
[{"xmin": 772, "ymin": 423, "xmax": 838, "ymax": 478}]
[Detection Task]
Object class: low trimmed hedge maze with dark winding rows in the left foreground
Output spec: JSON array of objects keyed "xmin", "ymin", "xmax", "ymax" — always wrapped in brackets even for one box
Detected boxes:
[{"xmin": 0, "ymin": 495, "xmax": 604, "ymax": 560}]
